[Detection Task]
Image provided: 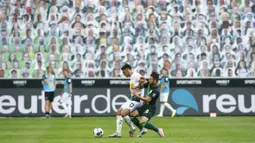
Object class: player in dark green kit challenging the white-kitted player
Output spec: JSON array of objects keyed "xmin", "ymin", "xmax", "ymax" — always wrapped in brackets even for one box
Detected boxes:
[{"xmin": 130, "ymin": 72, "xmax": 165, "ymax": 137}]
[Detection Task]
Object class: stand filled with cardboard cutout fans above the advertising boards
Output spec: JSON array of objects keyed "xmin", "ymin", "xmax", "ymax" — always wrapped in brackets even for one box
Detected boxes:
[{"xmin": 0, "ymin": 0, "xmax": 255, "ymax": 78}]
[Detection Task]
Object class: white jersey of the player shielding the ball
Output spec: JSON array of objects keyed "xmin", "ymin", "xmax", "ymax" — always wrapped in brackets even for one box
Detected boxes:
[{"xmin": 129, "ymin": 72, "xmax": 144, "ymax": 96}]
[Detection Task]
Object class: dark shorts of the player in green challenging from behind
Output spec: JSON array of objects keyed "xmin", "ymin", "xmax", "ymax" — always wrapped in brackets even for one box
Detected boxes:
[{"xmin": 137, "ymin": 104, "xmax": 156, "ymax": 120}]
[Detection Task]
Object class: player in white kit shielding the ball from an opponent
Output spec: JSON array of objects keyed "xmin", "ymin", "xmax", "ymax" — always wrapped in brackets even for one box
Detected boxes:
[{"xmin": 109, "ymin": 64, "xmax": 147, "ymax": 138}]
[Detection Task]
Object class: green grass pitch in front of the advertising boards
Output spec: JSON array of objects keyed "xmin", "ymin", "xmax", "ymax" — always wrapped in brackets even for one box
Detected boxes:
[{"xmin": 0, "ymin": 117, "xmax": 255, "ymax": 143}]
